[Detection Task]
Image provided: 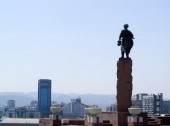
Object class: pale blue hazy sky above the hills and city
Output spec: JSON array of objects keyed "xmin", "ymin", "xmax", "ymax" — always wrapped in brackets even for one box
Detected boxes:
[{"xmin": 0, "ymin": 0, "xmax": 170, "ymax": 98}]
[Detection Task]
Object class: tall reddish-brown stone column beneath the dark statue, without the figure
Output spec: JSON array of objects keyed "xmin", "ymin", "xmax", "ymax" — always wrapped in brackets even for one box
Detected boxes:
[{"xmin": 117, "ymin": 58, "xmax": 132, "ymax": 126}]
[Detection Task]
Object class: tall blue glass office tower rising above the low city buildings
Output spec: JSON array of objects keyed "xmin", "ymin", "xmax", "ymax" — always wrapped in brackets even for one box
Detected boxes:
[{"xmin": 38, "ymin": 79, "xmax": 51, "ymax": 118}]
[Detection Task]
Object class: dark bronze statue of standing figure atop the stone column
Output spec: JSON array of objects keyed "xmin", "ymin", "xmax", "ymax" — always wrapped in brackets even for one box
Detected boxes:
[{"xmin": 118, "ymin": 24, "xmax": 134, "ymax": 58}]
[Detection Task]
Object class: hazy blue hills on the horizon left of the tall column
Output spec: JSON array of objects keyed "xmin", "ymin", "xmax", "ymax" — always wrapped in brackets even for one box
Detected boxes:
[{"xmin": 0, "ymin": 92, "xmax": 116, "ymax": 107}]
